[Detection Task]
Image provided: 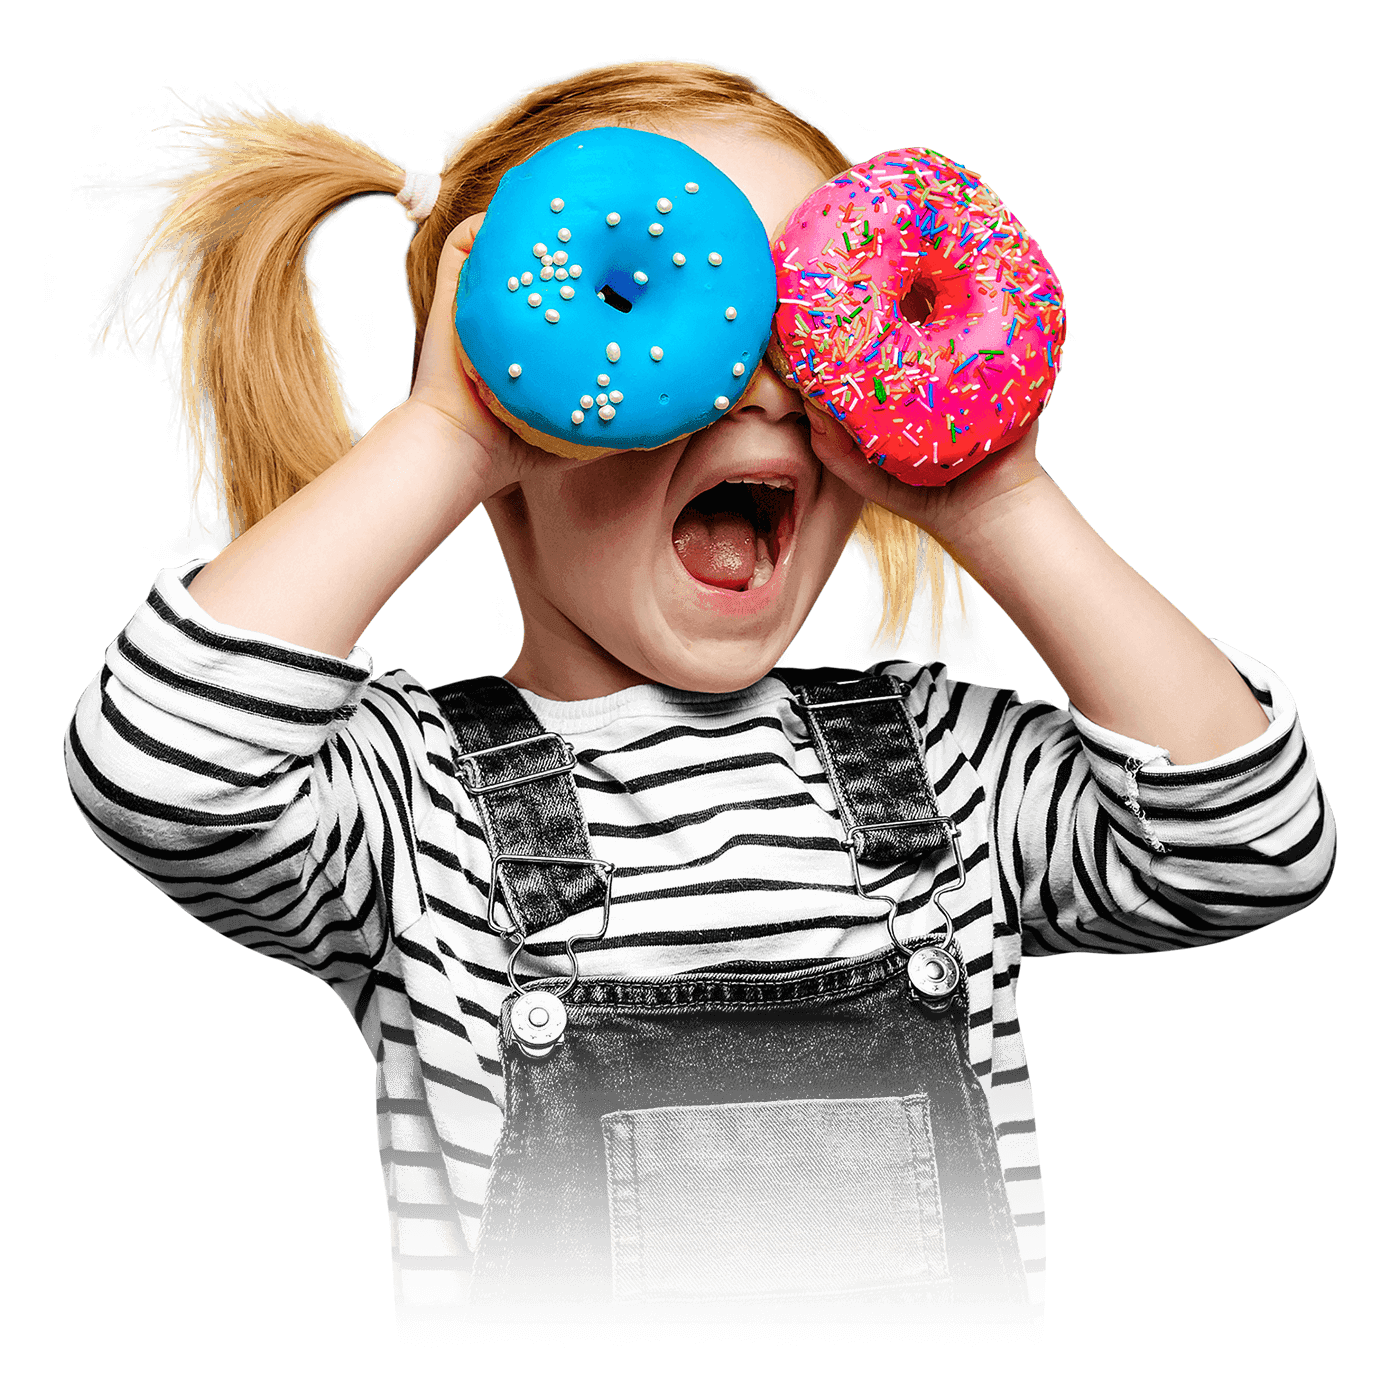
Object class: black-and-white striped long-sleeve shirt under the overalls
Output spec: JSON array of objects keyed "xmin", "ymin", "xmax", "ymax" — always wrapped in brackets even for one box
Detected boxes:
[{"xmin": 66, "ymin": 564, "xmax": 1336, "ymax": 1305}]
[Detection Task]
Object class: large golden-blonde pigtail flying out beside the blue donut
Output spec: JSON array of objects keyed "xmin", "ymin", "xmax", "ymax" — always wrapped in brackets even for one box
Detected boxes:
[{"xmin": 94, "ymin": 105, "xmax": 405, "ymax": 538}]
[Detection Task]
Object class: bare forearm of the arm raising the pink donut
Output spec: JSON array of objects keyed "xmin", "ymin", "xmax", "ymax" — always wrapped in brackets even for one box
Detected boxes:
[{"xmin": 938, "ymin": 470, "xmax": 1267, "ymax": 763}]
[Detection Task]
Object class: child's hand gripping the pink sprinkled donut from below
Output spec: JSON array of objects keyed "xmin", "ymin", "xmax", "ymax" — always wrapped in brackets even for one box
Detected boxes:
[{"xmin": 804, "ymin": 400, "xmax": 1046, "ymax": 556}]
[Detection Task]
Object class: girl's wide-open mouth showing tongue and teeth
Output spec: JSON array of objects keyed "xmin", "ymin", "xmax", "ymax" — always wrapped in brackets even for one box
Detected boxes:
[{"xmin": 671, "ymin": 477, "xmax": 795, "ymax": 592}]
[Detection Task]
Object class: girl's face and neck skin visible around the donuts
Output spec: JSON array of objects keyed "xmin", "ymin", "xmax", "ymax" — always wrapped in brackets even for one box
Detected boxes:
[{"xmin": 487, "ymin": 123, "xmax": 864, "ymax": 700}]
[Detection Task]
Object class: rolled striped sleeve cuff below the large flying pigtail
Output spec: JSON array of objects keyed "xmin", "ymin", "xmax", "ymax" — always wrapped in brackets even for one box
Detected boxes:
[{"xmin": 106, "ymin": 560, "xmax": 372, "ymax": 755}]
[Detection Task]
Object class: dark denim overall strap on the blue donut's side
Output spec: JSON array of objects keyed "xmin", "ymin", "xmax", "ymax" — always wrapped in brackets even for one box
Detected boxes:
[{"xmin": 431, "ymin": 676, "xmax": 610, "ymax": 939}]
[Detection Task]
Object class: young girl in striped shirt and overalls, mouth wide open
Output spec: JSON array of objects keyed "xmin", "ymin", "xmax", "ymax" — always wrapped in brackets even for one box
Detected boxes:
[{"xmin": 67, "ymin": 62, "xmax": 1334, "ymax": 1309}]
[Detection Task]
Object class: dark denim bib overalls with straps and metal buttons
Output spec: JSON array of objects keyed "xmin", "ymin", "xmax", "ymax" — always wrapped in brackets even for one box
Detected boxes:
[{"xmin": 433, "ymin": 668, "xmax": 1029, "ymax": 1317}]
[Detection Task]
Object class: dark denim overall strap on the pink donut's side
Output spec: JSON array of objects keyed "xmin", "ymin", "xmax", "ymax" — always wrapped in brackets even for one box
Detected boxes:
[{"xmin": 773, "ymin": 666, "xmax": 956, "ymax": 865}]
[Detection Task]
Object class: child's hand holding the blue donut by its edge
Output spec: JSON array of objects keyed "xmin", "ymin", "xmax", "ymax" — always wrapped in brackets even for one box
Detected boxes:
[{"xmin": 409, "ymin": 214, "xmax": 593, "ymax": 496}]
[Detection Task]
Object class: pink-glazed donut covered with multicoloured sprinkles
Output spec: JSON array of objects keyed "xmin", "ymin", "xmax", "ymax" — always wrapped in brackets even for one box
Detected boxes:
[{"xmin": 774, "ymin": 148, "xmax": 1064, "ymax": 486}]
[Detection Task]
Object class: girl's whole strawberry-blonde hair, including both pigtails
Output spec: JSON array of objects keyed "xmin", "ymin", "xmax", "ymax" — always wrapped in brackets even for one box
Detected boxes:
[{"xmin": 98, "ymin": 59, "xmax": 970, "ymax": 657}]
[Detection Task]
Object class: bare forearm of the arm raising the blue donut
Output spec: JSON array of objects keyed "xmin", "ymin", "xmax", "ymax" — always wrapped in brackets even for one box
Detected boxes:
[{"xmin": 190, "ymin": 402, "xmax": 487, "ymax": 657}]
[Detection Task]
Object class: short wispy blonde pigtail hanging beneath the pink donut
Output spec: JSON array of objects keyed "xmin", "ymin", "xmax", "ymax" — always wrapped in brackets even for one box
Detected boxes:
[{"xmin": 848, "ymin": 501, "xmax": 972, "ymax": 659}]
